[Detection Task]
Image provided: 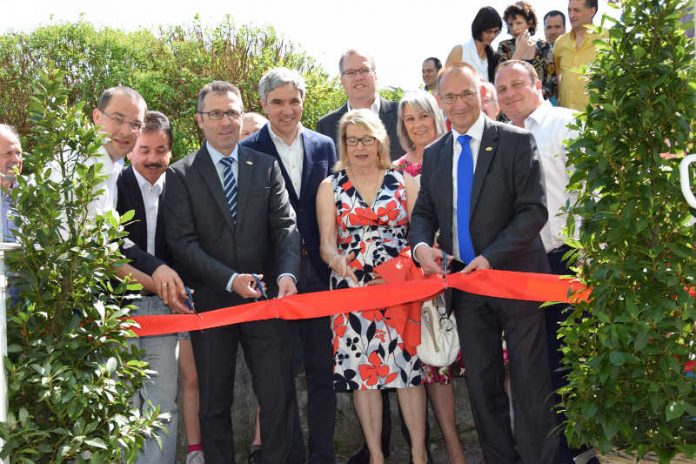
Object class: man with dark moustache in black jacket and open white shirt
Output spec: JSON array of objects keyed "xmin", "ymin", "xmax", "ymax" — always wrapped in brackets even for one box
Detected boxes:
[{"xmin": 116, "ymin": 111, "xmax": 190, "ymax": 464}]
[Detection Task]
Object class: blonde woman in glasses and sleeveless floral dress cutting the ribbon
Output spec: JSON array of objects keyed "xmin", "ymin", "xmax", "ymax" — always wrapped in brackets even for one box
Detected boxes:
[{"xmin": 317, "ymin": 109, "xmax": 427, "ymax": 464}]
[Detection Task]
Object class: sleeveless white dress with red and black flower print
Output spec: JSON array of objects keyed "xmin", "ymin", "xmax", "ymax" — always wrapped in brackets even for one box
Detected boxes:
[{"xmin": 331, "ymin": 170, "xmax": 421, "ymax": 391}]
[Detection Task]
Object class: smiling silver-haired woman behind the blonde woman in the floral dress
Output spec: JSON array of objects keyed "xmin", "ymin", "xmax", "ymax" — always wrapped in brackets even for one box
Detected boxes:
[{"xmin": 394, "ymin": 90, "xmax": 466, "ymax": 464}]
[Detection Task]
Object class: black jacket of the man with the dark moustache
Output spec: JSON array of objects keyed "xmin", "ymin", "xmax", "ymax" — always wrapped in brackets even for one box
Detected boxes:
[{"xmin": 116, "ymin": 166, "xmax": 170, "ymax": 275}]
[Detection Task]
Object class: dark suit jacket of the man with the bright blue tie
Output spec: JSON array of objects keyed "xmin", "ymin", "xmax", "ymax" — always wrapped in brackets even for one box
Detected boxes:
[{"xmin": 409, "ymin": 118, "xmax": 548, "ymax": 272}]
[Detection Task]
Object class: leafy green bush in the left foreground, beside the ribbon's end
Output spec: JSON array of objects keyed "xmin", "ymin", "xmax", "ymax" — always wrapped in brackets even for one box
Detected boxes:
[{"xmin": 0, "ymin": 73, "xmax": 159, "ymax": 464}]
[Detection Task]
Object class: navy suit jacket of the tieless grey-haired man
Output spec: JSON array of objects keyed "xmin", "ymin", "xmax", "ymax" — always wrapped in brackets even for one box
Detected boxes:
[{"xmin": 241, "ymin": 124, "xmax": 336, "ymax": 282}]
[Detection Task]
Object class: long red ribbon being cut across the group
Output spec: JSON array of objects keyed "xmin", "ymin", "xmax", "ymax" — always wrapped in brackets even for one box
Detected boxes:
[{"xmin": 132, "ymin": 254, "xmax": 589, "ymax": 336}]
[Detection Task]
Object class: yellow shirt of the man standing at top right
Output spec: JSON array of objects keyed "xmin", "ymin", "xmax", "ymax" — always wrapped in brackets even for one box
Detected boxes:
[{"xmin": 553, "ymin": 26, "xmax": 604, "ymax": 111}]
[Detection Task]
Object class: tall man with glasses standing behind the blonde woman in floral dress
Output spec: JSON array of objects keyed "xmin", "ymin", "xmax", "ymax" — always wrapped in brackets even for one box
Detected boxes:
[{"xmin": 317, "ymin": 49, "xmax": 404, "ymax": 160}]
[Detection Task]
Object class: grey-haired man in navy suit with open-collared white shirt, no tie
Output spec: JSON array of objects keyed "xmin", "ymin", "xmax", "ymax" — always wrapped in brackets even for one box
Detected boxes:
[{"xmin": 241, "ymin": 68, "xmax": 336, "ymax": 464}]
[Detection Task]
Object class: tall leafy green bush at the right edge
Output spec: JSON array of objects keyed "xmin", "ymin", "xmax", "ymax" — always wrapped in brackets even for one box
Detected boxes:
[{"xmin": 562, "ymin": 0, "xmax": 696, "ymax": 462}]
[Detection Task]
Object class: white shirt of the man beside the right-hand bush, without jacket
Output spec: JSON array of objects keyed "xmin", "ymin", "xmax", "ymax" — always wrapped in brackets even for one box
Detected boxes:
[{"xmin": 524, "ymin": 100, "xmax": 578, "ymax": 253}]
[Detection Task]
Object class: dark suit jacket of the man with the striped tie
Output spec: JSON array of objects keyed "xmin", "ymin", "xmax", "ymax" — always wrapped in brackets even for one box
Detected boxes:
[{"xmin": 164, "ymin": 144, "xmax": 300, "ymax": 311}]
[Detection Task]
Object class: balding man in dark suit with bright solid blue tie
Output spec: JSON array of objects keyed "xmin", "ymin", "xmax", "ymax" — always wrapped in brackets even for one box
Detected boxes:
[{"xmin": 409, "ymin": 65, "xmax": 558, "ymax": 464}]
